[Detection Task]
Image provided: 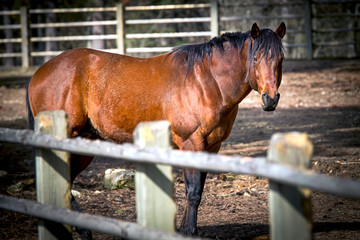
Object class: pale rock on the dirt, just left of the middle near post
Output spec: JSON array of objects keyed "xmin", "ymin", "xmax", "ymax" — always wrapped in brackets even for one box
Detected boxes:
[{"xmin": 104, "ymin": 168, "xmax": 135, "ymax": 190}]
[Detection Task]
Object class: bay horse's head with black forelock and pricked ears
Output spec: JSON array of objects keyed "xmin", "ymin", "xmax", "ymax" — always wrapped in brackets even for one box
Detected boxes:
[{"xmin": 247, "ymin": 22, "xmax": 286, "ymax": 111}]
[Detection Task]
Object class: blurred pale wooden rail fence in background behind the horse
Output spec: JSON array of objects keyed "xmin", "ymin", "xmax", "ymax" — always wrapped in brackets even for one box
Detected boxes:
[{"xmin": 0, "ymin": 0, "xmax": 360, "ymax": 68}]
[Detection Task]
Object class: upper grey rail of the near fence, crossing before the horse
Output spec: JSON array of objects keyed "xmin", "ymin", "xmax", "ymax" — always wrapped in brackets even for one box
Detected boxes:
[{"xmin": 0, "ymin": 125, "xmax": 360, "ymax": 199}]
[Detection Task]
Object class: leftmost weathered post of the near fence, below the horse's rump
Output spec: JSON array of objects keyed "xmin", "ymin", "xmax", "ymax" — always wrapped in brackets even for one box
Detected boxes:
[{"xmin": 35, "ymin": 111, "xmax": 72, "ymax": 239}]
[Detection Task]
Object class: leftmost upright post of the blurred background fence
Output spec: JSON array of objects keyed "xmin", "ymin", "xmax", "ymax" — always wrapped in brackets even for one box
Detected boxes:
[{"xmin": 20, "ymin": 6, "xmax": 30, "ymax": 68}]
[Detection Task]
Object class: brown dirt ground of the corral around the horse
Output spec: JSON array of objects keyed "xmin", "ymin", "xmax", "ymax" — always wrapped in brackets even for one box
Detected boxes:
[{"xmin": 0, "ymin": 60, "xmax": 360, "ymax": 240}]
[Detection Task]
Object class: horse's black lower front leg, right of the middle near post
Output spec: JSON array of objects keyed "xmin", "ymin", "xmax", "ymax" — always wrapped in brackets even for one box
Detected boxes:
[{"xmin": 180, "ymin": 169, "xmax": 207, "ymax": 236}]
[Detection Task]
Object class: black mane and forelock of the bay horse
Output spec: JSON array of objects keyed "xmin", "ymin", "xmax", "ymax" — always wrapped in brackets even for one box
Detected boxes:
[{"xmin": 171, "ymin": 29, "xmax": 283, "ymax": 73}]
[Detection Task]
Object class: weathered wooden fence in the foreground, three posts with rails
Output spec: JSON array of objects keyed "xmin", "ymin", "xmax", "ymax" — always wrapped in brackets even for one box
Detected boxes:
[{"xmin": 0, "ymin": 111, "xmax": 360, "ymax": 239}]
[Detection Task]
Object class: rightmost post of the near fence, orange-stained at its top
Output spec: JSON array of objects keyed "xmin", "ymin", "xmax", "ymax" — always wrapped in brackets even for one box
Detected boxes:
[{"xmin": 267, "ymin": 132, "xmax": 313, "ymax": 240}]
